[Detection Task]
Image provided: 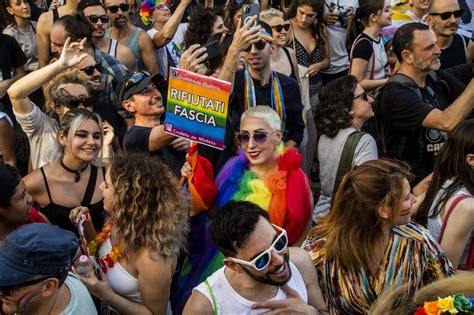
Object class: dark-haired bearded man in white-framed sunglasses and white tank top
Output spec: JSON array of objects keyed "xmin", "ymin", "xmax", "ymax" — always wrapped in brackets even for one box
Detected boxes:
[{"xmin": 183, "ymin": 201, "xmax": 327, "ymax": 314}]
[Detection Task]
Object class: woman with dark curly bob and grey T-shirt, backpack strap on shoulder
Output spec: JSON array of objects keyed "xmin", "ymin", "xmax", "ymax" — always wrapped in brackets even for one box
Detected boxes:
[{"xmin": 313, "ymin": 76, "xmax": 378, "ymax": 222}]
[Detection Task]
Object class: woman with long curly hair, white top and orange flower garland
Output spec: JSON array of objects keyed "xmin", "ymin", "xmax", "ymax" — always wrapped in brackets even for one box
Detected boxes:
[{"xmin": 70, "ymin": 153, "xmax": 189, "ymax": 314}]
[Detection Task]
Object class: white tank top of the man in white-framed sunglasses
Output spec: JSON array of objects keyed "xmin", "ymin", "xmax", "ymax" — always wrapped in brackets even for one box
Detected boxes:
[{"xmin": 193, "ymin": 261, "xmax": 308, "ymax": 314}]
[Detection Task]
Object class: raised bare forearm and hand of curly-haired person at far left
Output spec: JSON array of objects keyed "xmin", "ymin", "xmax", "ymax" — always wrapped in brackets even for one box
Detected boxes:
[{"xmin": 8, "ymin": 38, "xmax": 87, "ymax": 114}]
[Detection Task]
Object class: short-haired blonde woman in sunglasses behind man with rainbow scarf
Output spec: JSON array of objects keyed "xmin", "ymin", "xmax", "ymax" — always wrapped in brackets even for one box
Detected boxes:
[{"xmin": 259, "ymin": 8, "xmax": 299, "ymax": 81}]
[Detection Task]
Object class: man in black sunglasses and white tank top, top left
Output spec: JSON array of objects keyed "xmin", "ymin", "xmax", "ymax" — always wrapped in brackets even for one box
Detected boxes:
[{"xmin": 77, "ymin": 0, "xmax": 137, "ymax": 71}]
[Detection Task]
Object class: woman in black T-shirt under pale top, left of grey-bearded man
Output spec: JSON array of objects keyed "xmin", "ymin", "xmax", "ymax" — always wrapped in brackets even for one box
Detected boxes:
[{"xmin": 347, "ymin": 0, "xmax": 392, "ymax": 91}]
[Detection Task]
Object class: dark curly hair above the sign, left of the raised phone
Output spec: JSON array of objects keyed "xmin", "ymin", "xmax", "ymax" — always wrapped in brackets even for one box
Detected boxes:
[{"xmin": 184, "ymin": 7, "xmax": 224, "ymax": 49}]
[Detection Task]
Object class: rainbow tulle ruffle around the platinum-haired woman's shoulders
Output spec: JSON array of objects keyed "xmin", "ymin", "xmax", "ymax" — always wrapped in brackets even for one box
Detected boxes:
[{"xmin": 215, "ymin": 149, "xmax": 312, "ymax": 244}]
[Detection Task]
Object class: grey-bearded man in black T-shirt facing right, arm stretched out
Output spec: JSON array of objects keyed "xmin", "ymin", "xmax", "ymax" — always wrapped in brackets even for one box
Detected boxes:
[{"xmin": 376, "ymin": 23, "xmax": 474, "ymax": 184}]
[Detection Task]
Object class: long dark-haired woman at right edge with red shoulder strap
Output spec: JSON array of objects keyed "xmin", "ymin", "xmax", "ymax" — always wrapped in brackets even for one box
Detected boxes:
[{"xmin": 415, "ymin": 120, "xmax": 474, "ymax": 270}]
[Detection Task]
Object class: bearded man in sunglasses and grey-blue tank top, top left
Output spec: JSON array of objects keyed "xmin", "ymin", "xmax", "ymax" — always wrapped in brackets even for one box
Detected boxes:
[{"xmin": 104, "ymin": 0, "xmax": 159, "ymax": 73}]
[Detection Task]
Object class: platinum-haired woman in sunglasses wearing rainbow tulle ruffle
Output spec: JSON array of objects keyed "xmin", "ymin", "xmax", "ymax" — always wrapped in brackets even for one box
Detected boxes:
[{"xmin": 182, "ymin": 105, "xmax": 312, "ymax": 246}]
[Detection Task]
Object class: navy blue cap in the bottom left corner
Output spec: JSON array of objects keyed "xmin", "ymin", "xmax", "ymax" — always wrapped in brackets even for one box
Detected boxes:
[{"xmin": 0, "ymin": 223, "xmax": 79, "ymax": 287}]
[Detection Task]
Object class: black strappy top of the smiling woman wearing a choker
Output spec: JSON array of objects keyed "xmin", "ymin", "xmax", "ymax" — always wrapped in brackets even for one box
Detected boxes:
[{"xmin": 40, "ymin": 164, "xmax": 105, "ymax": 235}]
